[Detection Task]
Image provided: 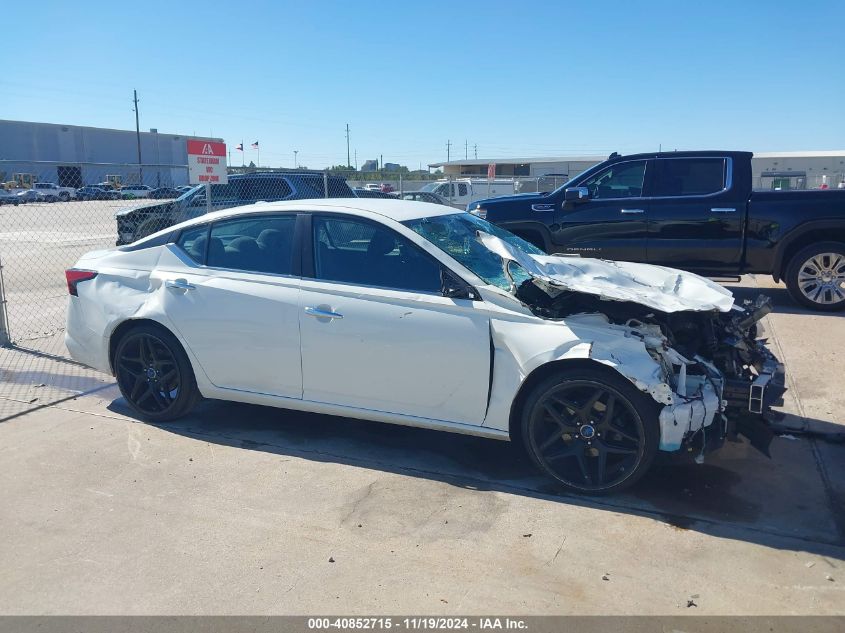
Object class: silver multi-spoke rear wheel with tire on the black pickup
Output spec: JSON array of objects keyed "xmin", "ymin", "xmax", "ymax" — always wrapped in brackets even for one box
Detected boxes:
[{"xmin": 784, "ymin": 242, "xmax": 845, "ymax": 312}]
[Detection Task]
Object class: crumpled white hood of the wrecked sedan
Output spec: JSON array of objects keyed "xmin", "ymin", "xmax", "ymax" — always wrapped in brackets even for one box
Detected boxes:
[{"xmin": 478, "ymin": 232, "xmax": 734, "ymax": 312}]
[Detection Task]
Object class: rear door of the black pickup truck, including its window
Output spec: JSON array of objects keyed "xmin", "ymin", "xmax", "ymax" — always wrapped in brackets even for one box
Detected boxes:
[{"xmin": 647, "ymin": 156, "xmax": 746, "ymax": 273}]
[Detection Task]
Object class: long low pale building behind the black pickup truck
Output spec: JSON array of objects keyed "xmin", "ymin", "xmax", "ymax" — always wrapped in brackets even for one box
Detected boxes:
[{"xmin": 429, "ymin": 150, "xmax": 845, "ymax": 190}]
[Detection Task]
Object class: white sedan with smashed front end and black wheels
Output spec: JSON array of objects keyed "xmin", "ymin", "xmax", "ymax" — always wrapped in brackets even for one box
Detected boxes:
[{"xmin": 66, "ymin": 199, "xmax": 784, "ymax": 493}]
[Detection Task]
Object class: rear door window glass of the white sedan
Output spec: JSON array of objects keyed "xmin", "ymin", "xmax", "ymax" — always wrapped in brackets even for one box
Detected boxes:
[{"xmin": 206, "ymin": 215, "xmax": 296, "ymax": 275}]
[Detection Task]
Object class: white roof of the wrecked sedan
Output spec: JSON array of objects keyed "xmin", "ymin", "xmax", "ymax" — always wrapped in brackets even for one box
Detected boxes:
[{"xmin": 185, "ymin": 198, "xmax": 461, "ymax": 226}]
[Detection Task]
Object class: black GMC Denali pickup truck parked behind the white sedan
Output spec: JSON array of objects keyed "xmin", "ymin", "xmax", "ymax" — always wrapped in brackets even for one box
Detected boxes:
[{"xmin": 467, "ymin": 151, "xmax": 845, "ymax": 311}]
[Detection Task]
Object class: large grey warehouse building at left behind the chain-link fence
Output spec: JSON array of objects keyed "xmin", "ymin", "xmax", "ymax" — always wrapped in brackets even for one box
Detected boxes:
[{"xmin": 0, "ymin": 120, "xmax": 222, "ymax": 187}]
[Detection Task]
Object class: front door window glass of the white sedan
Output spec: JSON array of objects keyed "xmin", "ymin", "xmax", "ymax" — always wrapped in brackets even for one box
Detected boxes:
[{"xmin": 314, "ymin": 217, "xmax": 441, "ymax": 292}]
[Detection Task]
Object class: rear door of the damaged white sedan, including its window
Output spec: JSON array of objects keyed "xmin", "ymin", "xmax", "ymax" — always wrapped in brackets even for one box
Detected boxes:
[{"xmin": 151, "ymin": 214, "xmax": 302, "ymax": 398}]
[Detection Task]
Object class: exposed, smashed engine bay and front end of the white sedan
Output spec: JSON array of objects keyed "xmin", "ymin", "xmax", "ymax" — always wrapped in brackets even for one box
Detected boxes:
[{"xmin": 516, "ymin": 279, "xmax": 786, "ymax": 455}]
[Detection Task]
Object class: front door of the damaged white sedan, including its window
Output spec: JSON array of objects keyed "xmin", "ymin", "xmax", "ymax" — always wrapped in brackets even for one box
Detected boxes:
[{"xmin": 300, "ymin": 214, "xmax": 491, "ymax": 425}]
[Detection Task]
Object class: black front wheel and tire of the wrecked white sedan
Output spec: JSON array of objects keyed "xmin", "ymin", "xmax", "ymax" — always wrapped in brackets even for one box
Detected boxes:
[{"xmin": 521, "ymin": 368, "xmax": 660, "ymax": 494}]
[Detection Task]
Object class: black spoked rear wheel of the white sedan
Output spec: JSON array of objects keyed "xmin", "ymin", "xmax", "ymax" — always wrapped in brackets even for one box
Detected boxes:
[{"xmin": 116, "ymin": 332, "xmax": 182, "ymax": 415}]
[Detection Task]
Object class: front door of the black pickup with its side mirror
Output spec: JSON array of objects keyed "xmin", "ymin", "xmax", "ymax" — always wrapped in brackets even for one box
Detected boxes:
[{"xmin": 552, "ymin": 160, "xmax": 651, "ymax": 262}]
